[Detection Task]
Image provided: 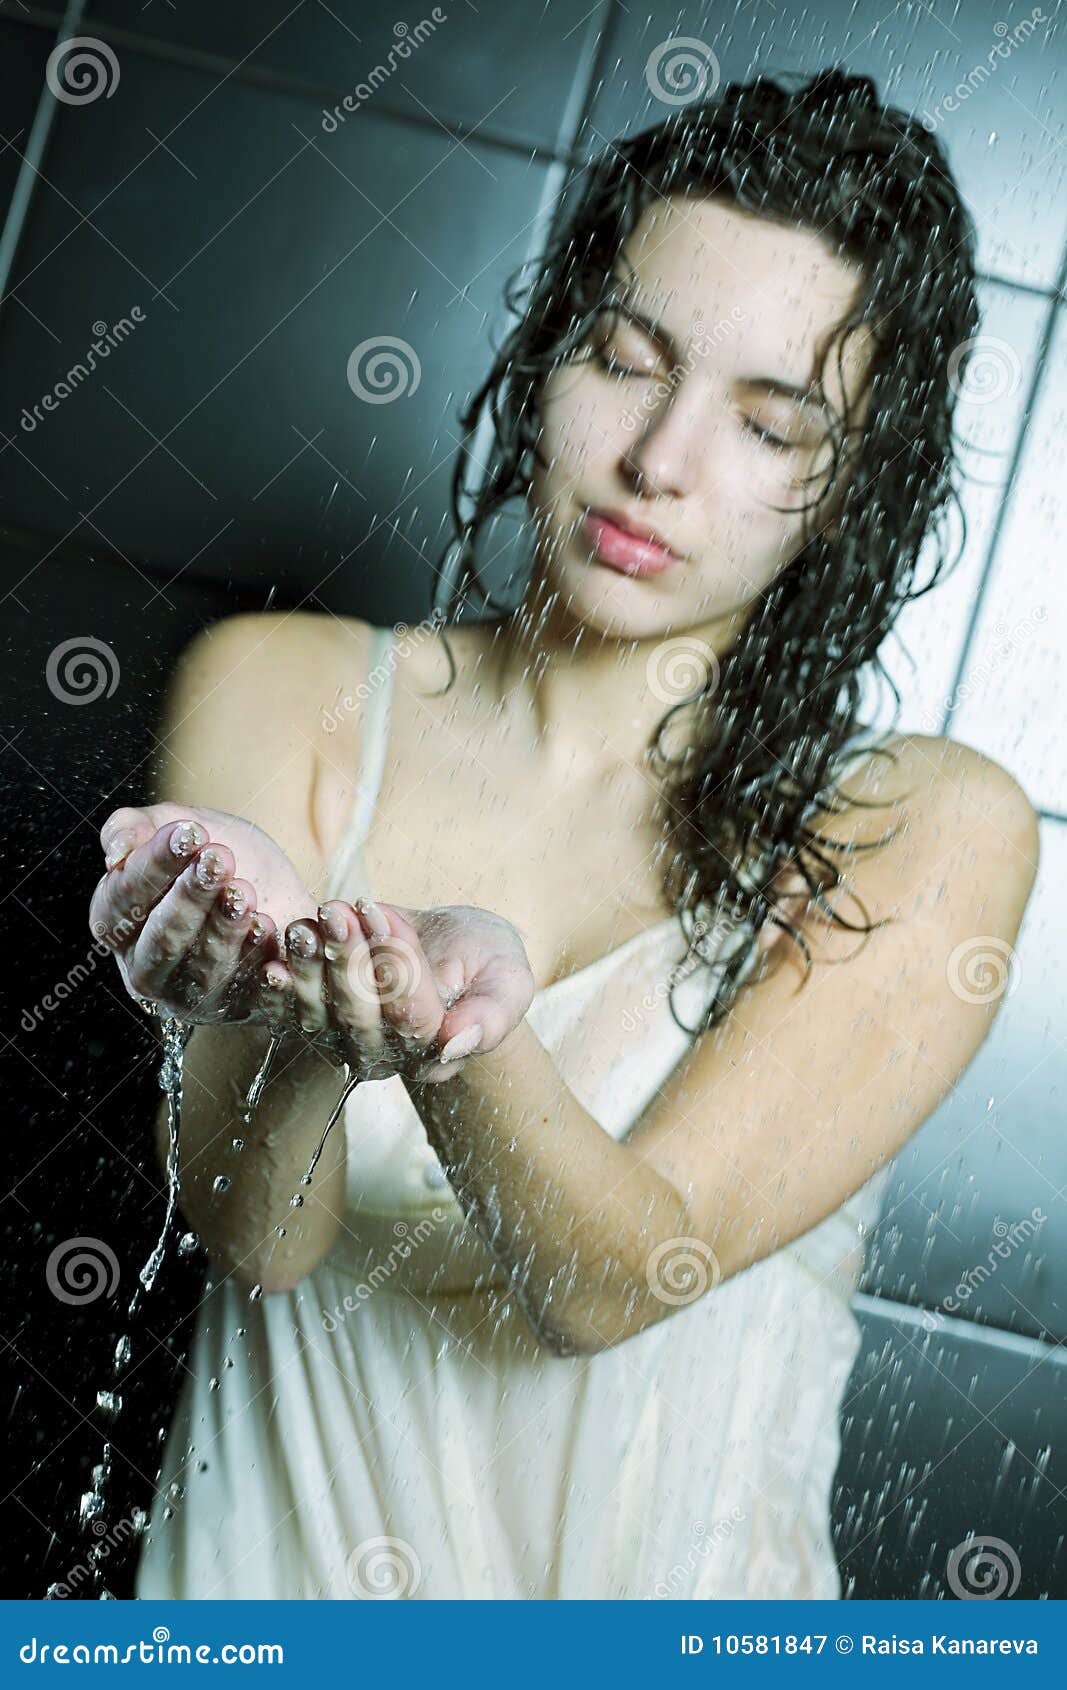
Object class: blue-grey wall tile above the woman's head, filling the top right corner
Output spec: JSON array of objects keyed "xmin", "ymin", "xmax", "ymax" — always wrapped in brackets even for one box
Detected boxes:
[{"xmin": 583, "ymin": 0, "xmax": 1067, "ymax": 286}]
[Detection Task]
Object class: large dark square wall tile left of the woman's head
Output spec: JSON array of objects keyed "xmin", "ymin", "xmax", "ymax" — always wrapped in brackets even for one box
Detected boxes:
[{"xmin": 0, "ymin": 52, "xmax": 544, "ymax": 613}]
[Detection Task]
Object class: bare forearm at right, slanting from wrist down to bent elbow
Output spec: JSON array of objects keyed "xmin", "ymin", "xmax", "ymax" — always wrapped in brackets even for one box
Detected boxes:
[{"xmin": 408, "ymin": 1021, "xmax": 687, "ymax": 1354}]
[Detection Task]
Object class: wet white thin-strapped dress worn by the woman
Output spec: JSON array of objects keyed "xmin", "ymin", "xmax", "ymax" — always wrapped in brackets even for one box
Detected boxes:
[{"xmin": 135, "ymin": 629, "xmax": 889, "ymax": 1599}]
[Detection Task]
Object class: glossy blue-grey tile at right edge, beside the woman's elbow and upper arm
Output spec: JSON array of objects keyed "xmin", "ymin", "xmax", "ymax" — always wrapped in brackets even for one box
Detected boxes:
[{"xmin": 862, "ymin": 821, "xmax": 1067, "ymax": 1342}]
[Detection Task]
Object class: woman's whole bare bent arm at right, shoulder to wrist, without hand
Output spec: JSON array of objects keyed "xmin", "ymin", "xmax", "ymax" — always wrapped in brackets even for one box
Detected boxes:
[{"xmin": 400, "ymin": 737, "xmax": 1038, "ymax": 1355}]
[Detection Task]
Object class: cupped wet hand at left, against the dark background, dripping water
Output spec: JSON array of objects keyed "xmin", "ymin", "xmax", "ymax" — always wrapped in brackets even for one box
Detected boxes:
[{"xmin": 90, "ymin": 803, "xmax": 309, "ymax": 1024}]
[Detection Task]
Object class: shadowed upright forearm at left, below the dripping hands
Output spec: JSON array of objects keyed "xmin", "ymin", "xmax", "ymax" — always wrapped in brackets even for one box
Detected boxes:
[{"xmin": 159, "ymin": 1026, "xmax": 345, "ymax": 1291}]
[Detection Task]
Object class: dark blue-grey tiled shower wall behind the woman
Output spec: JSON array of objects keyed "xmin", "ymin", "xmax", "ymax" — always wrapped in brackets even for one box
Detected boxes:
[{"xmin": 0, "ymin": 0, "xmax": 1067, "ymax": 1597}]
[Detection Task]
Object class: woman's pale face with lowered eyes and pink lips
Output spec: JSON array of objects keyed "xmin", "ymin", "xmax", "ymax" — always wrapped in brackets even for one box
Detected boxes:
[{"xmin": 529, "ymin": 198, "xmax": 873, "ymax": 639}]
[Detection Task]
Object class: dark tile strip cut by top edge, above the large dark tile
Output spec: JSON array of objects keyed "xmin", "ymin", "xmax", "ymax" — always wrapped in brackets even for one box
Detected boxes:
[{"xmin": 86, "ymin": 0, "xmax": 604, "ymax": 147}]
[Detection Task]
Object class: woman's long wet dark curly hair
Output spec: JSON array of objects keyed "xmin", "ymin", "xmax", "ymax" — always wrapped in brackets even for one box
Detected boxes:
[{"xmin": 421, "ymin": 68, "xmax": 979, "ymax": 1033}]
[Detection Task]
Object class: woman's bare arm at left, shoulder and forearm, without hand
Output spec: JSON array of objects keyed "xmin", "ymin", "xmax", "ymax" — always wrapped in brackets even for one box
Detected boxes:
[{"xmin": 132, "ymin": 615, "xmax": 369, "ymax": 1293}]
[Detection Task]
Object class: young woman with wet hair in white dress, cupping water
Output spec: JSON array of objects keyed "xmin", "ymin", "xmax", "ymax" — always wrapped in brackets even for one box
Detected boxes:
[{"xmin": 91, "ymin": 71, "xmax": 1037, "ymax": 1599}]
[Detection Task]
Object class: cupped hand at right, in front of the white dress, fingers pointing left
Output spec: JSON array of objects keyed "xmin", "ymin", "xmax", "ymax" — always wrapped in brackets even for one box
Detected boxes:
[{"xmin": 277, "ymin": 899, "xmax": 534, "ymax": 1083}]
